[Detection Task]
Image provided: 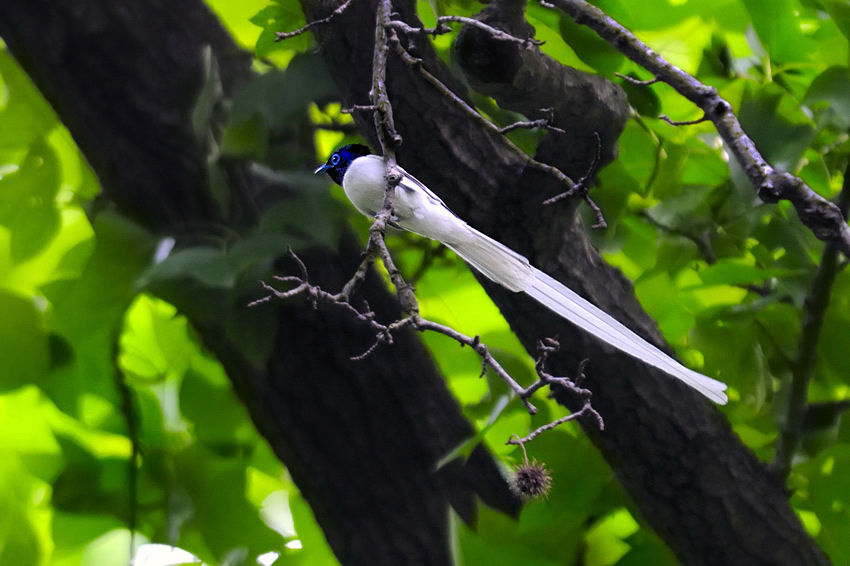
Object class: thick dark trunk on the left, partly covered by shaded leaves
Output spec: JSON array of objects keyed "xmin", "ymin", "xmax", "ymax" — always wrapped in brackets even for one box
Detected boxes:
[{"xmin": 0, "ymin": 0, "xmax": 518, "ymax": 566}]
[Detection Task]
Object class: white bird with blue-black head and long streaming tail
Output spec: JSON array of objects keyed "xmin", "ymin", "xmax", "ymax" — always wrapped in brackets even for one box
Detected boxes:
[{"xmin": 315, "ymin": 144, "xmax": 727, "ymax": 404}]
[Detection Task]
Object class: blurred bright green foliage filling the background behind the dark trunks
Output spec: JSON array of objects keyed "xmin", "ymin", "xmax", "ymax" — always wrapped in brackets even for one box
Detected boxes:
[{"xmin": 0, "ymin": 0, "xmax": 850, "ymax": 566}]
